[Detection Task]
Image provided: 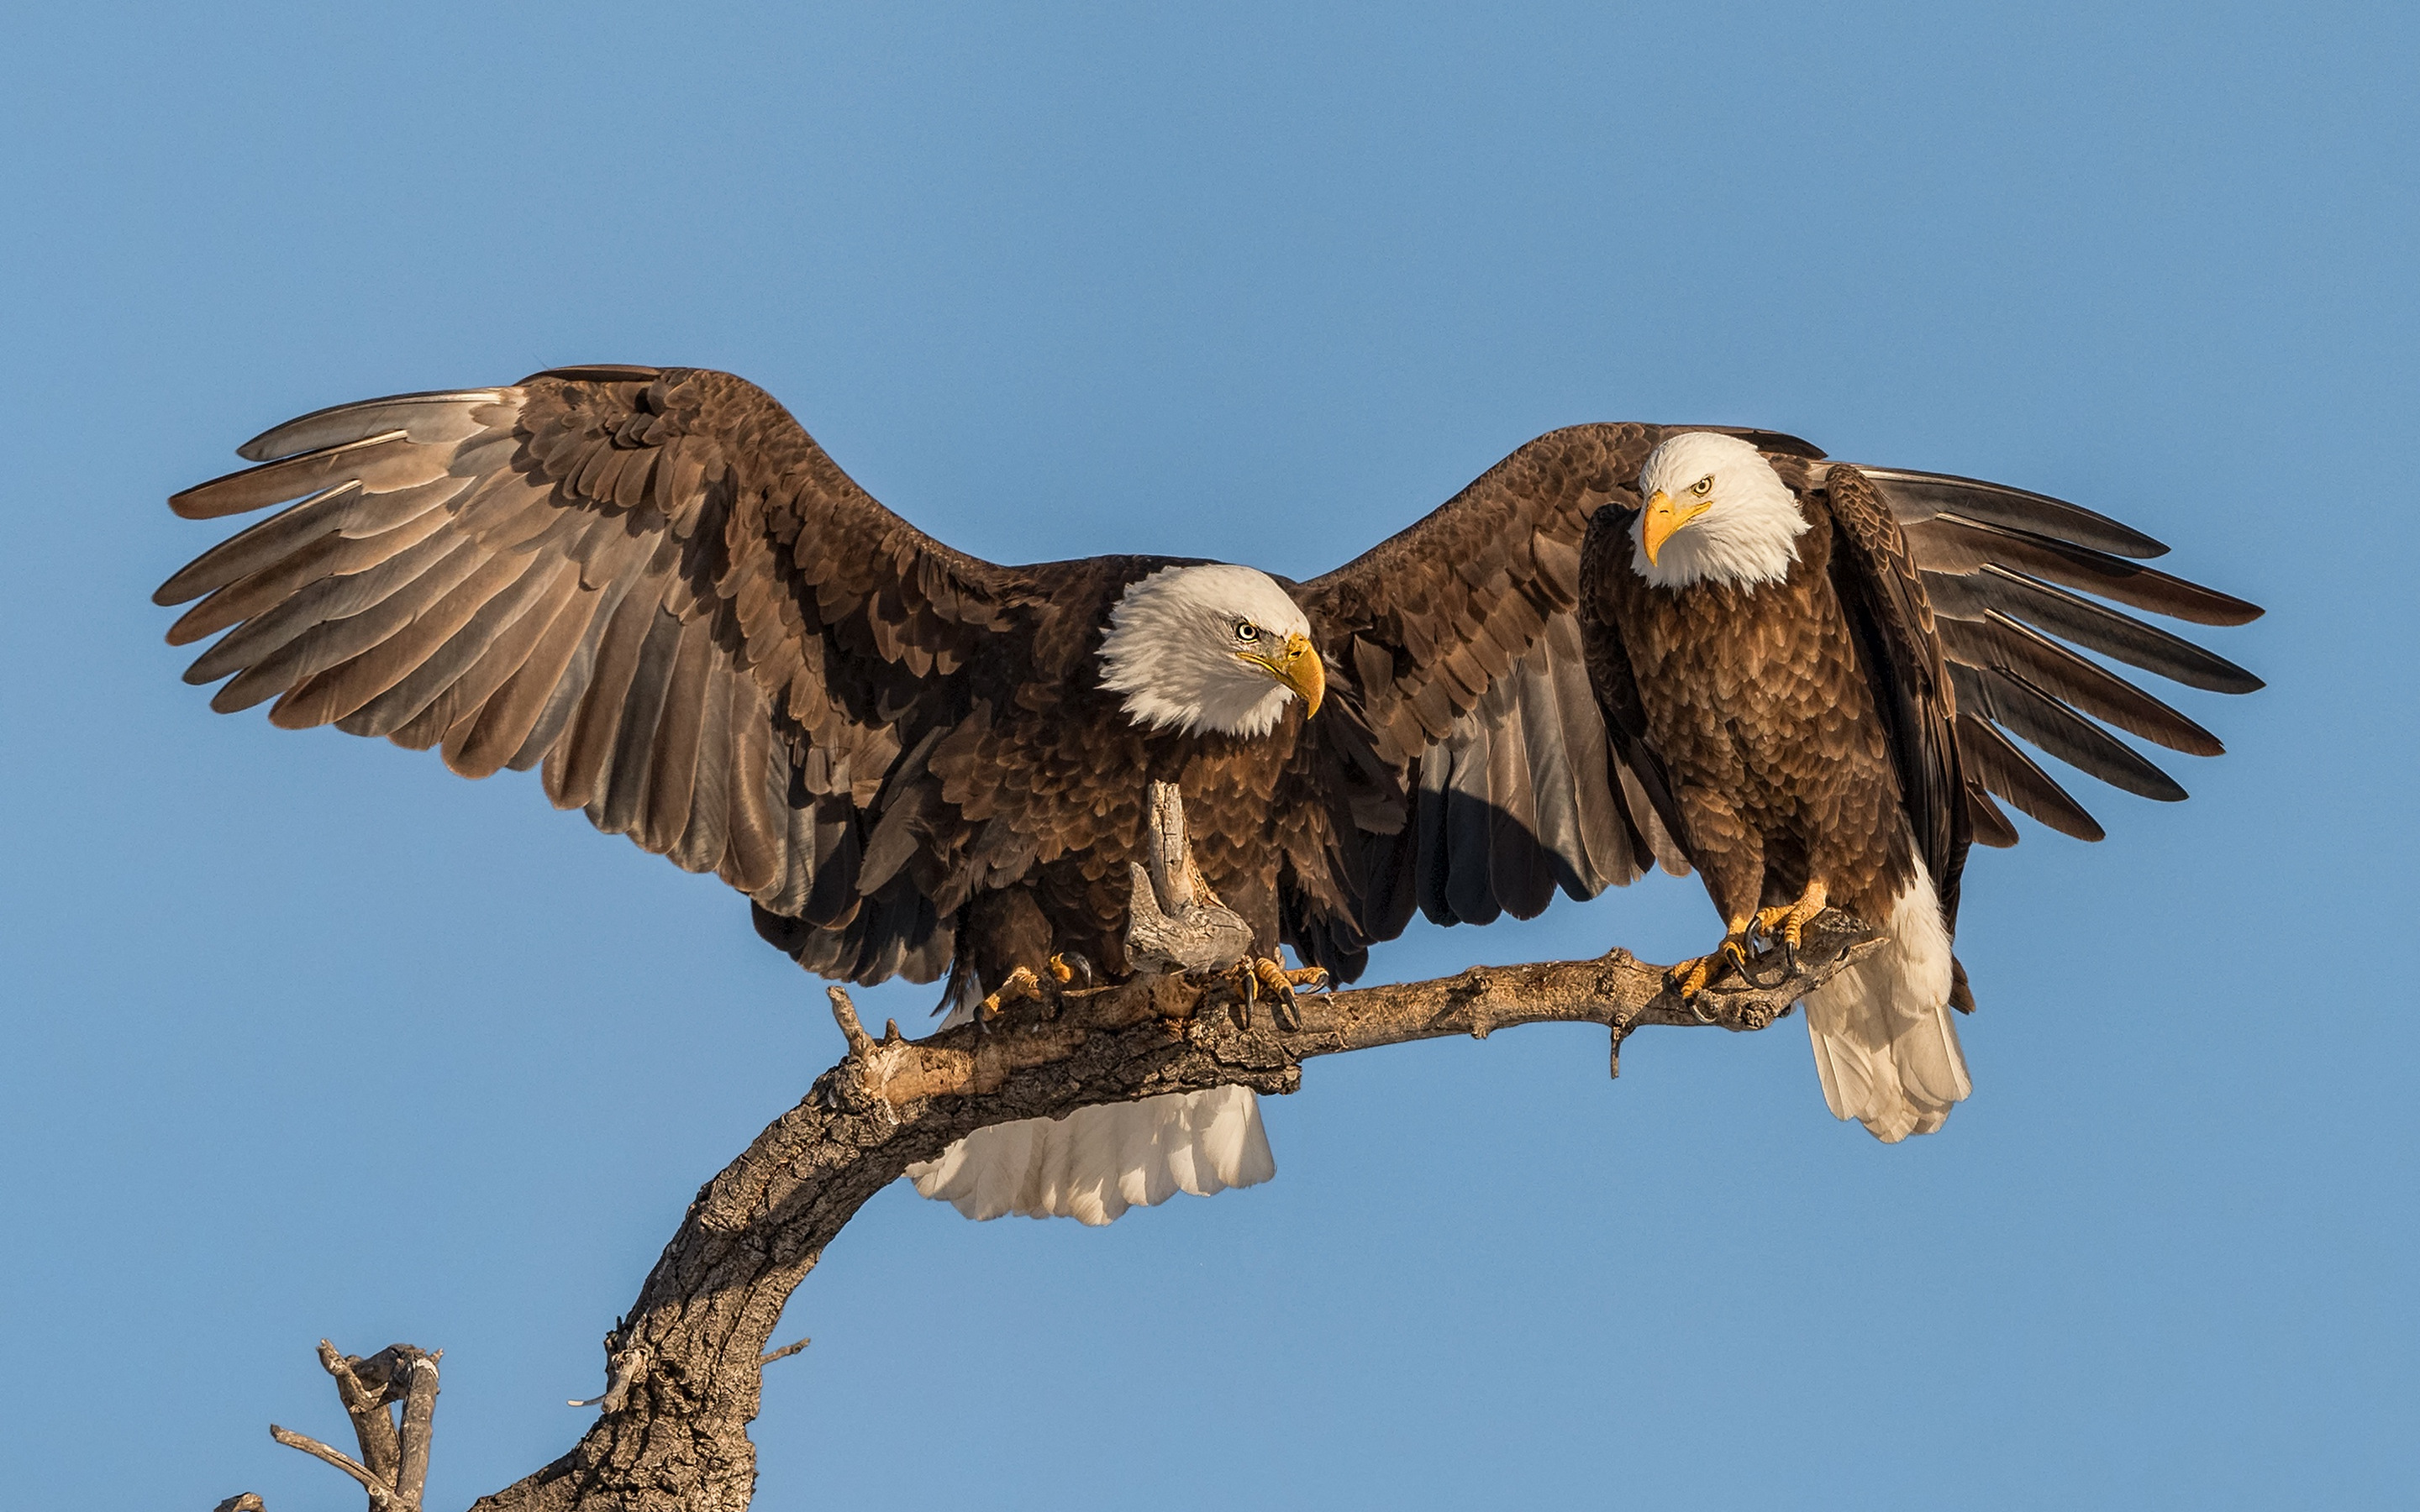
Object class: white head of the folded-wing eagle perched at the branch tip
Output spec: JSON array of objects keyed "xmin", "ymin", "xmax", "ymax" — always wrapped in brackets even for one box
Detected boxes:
[{"xmin": 1631, "ymin": 431, "xmax": 1807, "ymax": 588}]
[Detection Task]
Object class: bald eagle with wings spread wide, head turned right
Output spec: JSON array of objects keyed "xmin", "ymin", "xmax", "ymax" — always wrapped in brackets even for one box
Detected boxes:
[{"xmin": 157, "ymin": 368, "xmax": 1680, "ymax": 1221}]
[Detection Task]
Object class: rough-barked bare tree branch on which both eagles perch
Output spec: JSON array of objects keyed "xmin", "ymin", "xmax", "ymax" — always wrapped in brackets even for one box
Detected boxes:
[{"xmin": 227, "ymin": 784, "xmax": 1878, "ymax": 1512}]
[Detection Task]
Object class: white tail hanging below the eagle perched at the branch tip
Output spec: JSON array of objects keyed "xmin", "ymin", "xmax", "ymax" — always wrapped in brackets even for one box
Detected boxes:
[{"xmin": 1805, "ymin": 861, "xmax": 1975, "ymax": 1144}]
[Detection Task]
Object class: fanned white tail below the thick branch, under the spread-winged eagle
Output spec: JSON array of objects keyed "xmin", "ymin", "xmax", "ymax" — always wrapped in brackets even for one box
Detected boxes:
[{"xmin": 908, "ymin": 1086, "xmax": 1278, "ymax": 1226}]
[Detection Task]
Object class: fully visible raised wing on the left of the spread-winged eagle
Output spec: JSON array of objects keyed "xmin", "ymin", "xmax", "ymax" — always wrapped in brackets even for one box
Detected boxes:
[{"xmin": 155, "ymin": 368, "xmax": 1017, "ymax": 979}]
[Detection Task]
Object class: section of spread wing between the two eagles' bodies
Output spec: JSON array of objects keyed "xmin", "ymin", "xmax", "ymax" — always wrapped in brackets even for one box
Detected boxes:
[{"xmin": 1281, "ymin": 426, "xmax": 1684, "ymax": 978}]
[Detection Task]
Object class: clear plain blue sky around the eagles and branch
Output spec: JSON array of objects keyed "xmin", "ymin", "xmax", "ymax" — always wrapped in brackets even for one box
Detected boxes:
[{"xmin": 0, "ymin": 3, "xmax": 2420, "ymax": 1512}]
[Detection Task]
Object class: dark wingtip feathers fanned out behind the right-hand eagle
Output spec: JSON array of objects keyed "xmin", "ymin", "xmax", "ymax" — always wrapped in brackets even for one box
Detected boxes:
[{"xmin": 1827, "ymin": 465, "xmax": 2260, "ymax": 844}]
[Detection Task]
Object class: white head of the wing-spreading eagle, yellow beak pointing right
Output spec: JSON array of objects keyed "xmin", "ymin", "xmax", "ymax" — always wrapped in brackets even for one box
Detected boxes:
[{"xmin": 1101, "ymin": 564, "xmax": 1326, "ymax": 736}]
